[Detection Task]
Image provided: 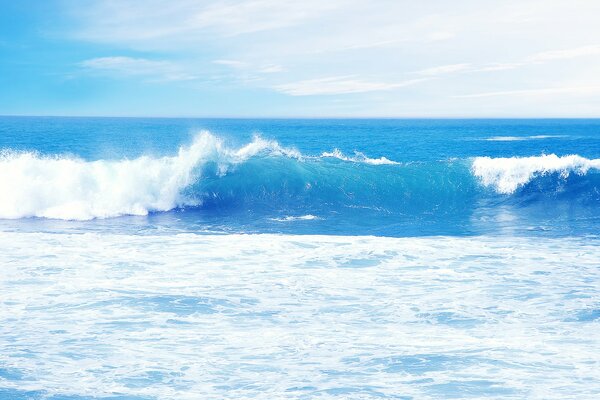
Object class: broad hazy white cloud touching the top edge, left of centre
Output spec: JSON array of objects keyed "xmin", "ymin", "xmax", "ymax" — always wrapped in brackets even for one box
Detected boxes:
[{"xmin": 71, "ymin": 0, "xmax": 344, "ymax": 43}]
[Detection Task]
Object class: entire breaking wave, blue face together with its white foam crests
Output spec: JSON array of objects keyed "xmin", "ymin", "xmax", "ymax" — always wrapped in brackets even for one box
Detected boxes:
[{"xmin": 0, "ymin": 132, "xmax": 600, "ymax": 221}]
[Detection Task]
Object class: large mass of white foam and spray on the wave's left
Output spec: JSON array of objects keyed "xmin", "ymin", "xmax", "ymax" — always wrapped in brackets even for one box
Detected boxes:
[{"xmin": 0, "ymin": 131, "xmax": 301, "ymax": 220}]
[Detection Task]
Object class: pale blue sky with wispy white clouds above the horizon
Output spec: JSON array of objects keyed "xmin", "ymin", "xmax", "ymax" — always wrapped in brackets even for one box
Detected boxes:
[{"xmin": 0, "ymin": 0, "xmax": 600, "ymax": 118}]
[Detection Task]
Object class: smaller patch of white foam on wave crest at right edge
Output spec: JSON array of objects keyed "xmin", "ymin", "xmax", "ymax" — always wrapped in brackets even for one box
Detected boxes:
[{"xmin": 472, "ymin": 154, "xmax": 600, "ymax": 194}]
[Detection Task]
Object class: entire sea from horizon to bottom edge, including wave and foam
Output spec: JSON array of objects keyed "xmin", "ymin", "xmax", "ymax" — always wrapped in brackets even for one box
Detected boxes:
[{"xmin": 0, "ymin": 117, "xmax": 600, "ymax": 400}]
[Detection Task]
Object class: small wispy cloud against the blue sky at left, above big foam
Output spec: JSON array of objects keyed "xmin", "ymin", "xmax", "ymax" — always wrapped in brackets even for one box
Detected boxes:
[{"xmin": 80, "ymin": 56, "xmax": 197, "ymax": 81}]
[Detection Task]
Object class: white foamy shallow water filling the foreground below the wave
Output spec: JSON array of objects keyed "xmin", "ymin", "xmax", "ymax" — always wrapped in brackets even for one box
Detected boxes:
[{"xmin": 0, "ymin": 232, "xmax": 600, "ymax": 400}]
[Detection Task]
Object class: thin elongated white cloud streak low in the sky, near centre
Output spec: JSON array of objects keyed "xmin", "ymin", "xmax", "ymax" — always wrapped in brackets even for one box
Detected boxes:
[{"xmin": 274, "ymin": 76, "xmax": 427, "ymax": 96}]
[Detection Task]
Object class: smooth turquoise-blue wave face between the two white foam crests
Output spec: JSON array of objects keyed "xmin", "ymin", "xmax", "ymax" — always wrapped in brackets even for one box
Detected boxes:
[{"xmin": 184, "ymin": 157, "xmax": 483, "ymax": 216}]
